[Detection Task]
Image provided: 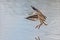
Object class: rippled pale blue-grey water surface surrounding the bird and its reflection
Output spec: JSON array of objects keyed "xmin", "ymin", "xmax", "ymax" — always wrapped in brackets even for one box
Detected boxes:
[{"xmin": 0, "ymin": 0, "xmax": 60, "ymax": 40}]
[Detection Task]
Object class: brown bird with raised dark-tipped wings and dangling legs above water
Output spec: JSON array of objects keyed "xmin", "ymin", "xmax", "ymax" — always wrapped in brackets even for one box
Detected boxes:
[{"xmin": 26, "ymin": 6, "xmax": 47, "ymax": 29}]
